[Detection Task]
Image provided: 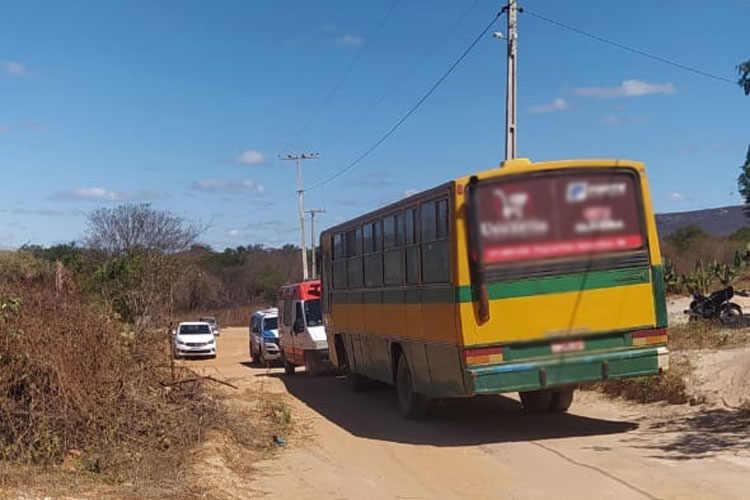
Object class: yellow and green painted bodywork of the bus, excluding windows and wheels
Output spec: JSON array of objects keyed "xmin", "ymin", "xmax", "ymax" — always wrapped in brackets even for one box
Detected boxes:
[{"xmin": 321, "ymin": 159, "xmax": 668, "ymax": 397}]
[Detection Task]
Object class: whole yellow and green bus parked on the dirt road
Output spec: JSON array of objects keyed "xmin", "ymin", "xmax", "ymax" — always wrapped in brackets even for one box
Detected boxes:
[{"xmin": 321, "ymin": 159, "xmax": 669, "ymax": 418}]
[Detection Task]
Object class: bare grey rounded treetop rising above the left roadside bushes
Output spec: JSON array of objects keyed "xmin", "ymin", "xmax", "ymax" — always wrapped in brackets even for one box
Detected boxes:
[{"xmin": 86, "ymin": 203, "xmax": 203, "ymax": 256}]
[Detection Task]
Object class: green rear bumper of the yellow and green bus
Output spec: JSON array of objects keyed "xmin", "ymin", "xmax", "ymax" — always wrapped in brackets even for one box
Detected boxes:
[{"xmin": 464, "ymin": 346, "xmax": 669, "ymax": 394}]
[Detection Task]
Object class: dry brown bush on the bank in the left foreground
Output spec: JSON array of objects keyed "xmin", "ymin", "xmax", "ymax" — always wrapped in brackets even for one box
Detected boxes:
[{"xmin": 0, "ymin": 254, "xmax": 220, "ymax": 478}]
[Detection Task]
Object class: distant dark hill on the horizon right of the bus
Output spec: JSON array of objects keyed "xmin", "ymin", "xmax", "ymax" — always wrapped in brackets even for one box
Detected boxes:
[{"xmin": 656, "ymin": 205, "xmax": 750, "ymax": 237}]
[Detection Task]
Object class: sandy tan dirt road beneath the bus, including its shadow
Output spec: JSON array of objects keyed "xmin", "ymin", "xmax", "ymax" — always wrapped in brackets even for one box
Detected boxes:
[{"xmin": 182, "ymin": 328, "xmax": 750, "ymax": 500}]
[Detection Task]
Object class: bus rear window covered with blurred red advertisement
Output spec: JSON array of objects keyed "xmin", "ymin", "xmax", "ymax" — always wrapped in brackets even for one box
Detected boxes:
[{"xmin": 476, "ymin": 171, "xmax": 645, "ymax": 264}]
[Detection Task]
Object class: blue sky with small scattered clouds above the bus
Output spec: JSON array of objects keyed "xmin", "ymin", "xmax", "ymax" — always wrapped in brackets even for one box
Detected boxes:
[{"xmin": 0, "ymin": 0, "xmax": 750, "ymax": 249}]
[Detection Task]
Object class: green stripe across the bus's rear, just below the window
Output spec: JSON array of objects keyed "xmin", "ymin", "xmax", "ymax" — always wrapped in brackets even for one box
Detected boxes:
[{"xmin": 458, "ymin": 267, "xmax": 649, "ymax": 302}]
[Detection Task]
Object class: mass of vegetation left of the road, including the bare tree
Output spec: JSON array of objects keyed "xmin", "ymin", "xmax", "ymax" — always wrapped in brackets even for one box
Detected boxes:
[{"xmin": 0, "ymin": 205, "xmax": 296, "ymax": 497}]
